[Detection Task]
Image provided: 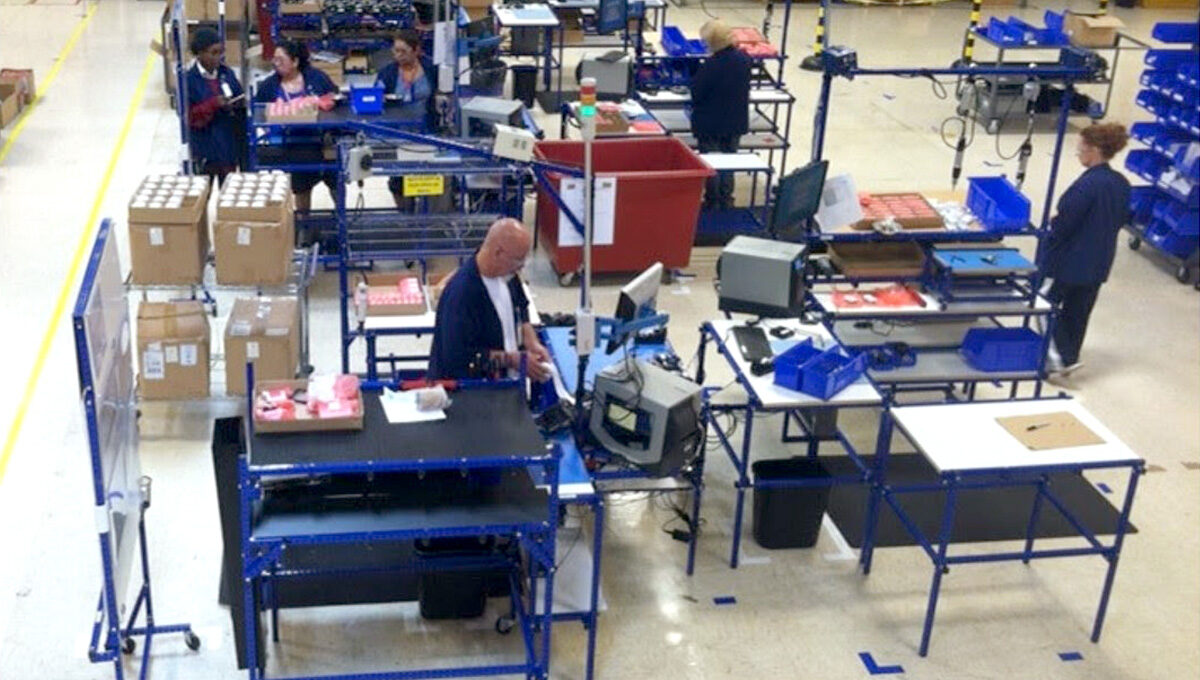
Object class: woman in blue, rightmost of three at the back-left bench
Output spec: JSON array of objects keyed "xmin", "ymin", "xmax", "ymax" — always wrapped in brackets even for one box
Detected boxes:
[{"xmin": 376, "ymin": 29, "xmax": 438, "ymax": 210}]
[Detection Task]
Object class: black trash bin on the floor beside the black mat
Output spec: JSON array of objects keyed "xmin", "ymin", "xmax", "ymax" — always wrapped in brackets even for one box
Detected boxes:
[{"xmin": 750, "ymin": 457, "xmax": 829, "ymax": 549}]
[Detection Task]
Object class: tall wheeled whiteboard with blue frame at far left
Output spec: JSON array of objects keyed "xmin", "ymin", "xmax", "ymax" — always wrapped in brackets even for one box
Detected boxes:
[{"xmin": 72, "ymin": 219, "xmax": 200, "ymax": 680}]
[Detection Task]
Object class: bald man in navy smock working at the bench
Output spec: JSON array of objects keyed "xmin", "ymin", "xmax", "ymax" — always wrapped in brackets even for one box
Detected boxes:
[{"xmin": 428, "ymin": 217, "xmax": 551, "ymax": 383}]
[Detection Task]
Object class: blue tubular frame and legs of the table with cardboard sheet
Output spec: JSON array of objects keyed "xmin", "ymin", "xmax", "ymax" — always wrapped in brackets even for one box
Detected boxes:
[{"xmin": 859, "ymin": 397, "xmax": 1145, "ymax": 656}]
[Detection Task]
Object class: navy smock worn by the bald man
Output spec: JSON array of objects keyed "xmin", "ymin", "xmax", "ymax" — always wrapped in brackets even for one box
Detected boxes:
[{"xmin": 428, "ymin": 257, "xmax": 529, "ymax": 380}]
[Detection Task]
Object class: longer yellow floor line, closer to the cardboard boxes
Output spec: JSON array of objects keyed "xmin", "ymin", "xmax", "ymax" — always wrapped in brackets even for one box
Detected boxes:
[{"xmin": 0, "ymin": 53, "xmax": 158, "ymax": 483}]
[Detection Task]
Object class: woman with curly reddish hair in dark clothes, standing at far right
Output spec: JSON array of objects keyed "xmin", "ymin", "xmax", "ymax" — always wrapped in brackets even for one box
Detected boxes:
[{"xmin": 1040, "ymin": 124, "xmax": 1129, "ymax": 375}]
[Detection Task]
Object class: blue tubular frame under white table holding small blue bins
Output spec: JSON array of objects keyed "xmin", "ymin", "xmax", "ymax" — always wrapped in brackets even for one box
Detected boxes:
[{"xmin": 688, "ymin": 323, "xmax": 884, "ymax": 576}]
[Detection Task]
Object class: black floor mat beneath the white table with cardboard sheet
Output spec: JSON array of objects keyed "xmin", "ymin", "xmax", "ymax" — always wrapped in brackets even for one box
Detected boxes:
[{"xmin": 821, "ymin": 453, "xmax": 1136, "ymax": 548}]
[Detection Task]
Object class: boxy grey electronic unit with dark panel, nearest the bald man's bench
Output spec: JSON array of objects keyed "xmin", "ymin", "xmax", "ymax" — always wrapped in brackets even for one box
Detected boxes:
[{"xmin": 588, "ymin": 361, "xmax": 704, "ymax": 477}]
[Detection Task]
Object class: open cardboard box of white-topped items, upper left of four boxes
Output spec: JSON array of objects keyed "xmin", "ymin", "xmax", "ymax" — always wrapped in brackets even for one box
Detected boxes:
[{"xmin": 130, "ymin": 175, "xmax": 209, "ymax": 285}]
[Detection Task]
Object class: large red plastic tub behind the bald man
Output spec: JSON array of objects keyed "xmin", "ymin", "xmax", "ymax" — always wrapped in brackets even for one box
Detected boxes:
[{"xmin": 534, "ymin": 137, "xmax": 715, "ymax": 275}]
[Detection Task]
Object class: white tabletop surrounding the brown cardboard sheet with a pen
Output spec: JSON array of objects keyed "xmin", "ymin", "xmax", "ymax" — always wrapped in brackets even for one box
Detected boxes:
[{"xmin": 892, "ymin": 399, "xmax": 1141, "ymax": 473}]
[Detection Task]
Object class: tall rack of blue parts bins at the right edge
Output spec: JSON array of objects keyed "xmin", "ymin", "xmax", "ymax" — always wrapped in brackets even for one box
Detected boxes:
[{"xmin": 1126, "ymin": 23, "xmax": 1200, "ymax": 288}]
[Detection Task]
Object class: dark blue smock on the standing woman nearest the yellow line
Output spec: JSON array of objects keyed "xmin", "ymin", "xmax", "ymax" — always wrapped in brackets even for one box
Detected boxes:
[{"xmin": 184, "ymin": 64, "xmax": 244, "ymax": 169}]
